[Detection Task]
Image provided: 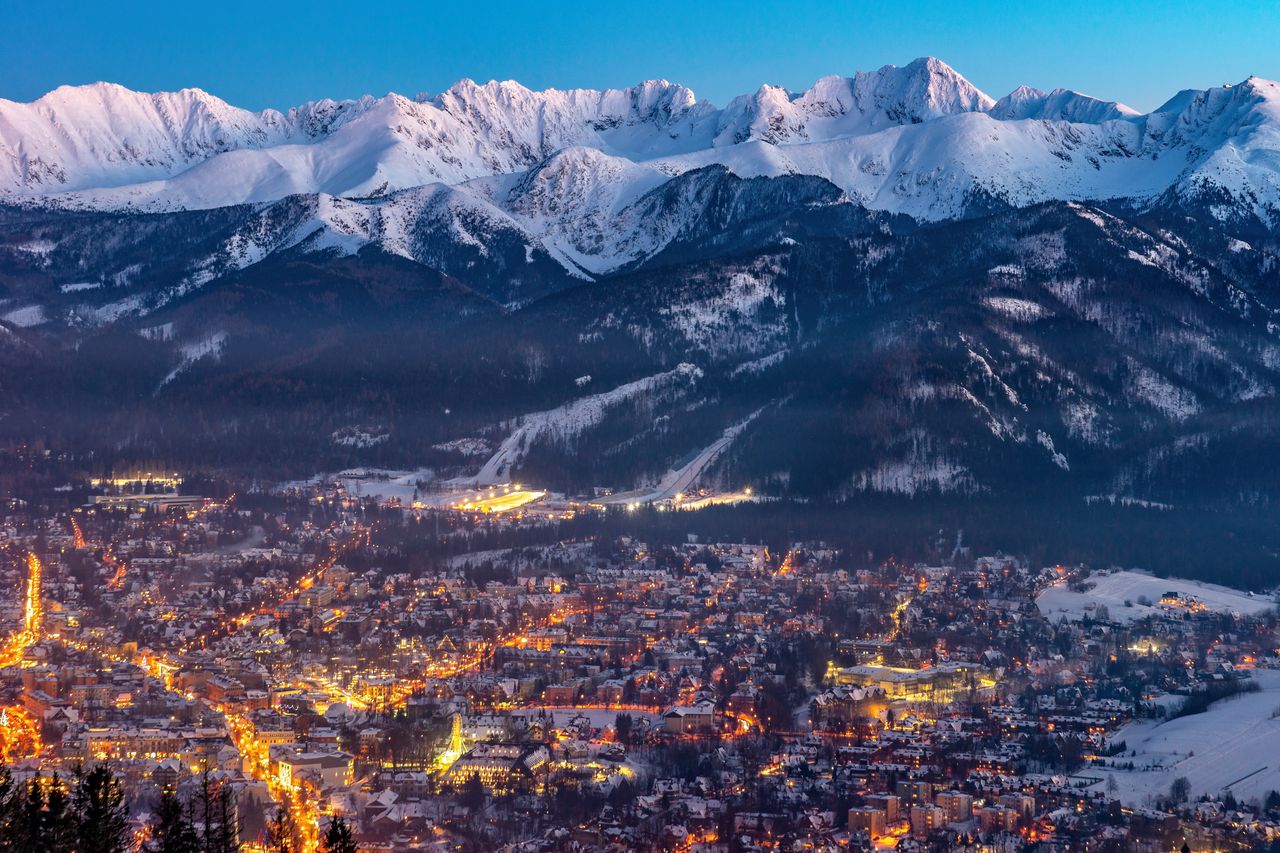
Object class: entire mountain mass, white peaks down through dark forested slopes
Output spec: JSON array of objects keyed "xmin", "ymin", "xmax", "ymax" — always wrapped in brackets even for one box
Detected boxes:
[{"xmin": 0, "ymin": 63, "xmax": 1280, "ymax": 578}]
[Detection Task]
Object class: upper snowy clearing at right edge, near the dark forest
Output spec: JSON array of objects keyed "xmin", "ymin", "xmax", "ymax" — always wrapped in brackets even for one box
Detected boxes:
[{"xmin": 1036, "ymin": 571, "xmax": 1275, "ymax": 622}]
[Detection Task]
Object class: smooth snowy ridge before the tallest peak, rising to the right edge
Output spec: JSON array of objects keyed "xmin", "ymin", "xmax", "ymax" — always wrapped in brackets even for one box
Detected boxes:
[{"xmin": 654, "ymin": 79, "xmax": 1280, "ymax": 228}]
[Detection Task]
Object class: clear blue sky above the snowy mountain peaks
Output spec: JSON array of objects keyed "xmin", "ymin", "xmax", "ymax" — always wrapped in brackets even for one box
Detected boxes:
[{"xmin": 0, "ymin": 0, "xmax": 1280, "ymax": 110}]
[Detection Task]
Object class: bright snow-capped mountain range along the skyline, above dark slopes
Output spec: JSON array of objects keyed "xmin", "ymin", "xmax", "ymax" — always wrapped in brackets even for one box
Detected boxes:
[{"xmin": 0, "ymin": 58, "xmax": 1280, "ymax": 277}]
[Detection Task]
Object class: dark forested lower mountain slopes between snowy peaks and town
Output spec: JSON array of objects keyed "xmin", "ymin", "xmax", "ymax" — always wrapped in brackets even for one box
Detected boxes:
[{"xmin": 0, "ymin": 178, "xmax": 1280, "ymax": 503}]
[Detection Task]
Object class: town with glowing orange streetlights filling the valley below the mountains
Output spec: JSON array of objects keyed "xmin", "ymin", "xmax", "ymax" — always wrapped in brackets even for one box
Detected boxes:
[{"xmin": 0, "ymin": 466, "xmax": 1280, "ymax": 853}]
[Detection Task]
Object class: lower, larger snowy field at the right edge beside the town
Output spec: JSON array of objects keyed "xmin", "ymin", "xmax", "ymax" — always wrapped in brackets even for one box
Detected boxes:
[{"xmin": 1083, "ymin": 670, "xmax": 1280, "ymax": 806}]
